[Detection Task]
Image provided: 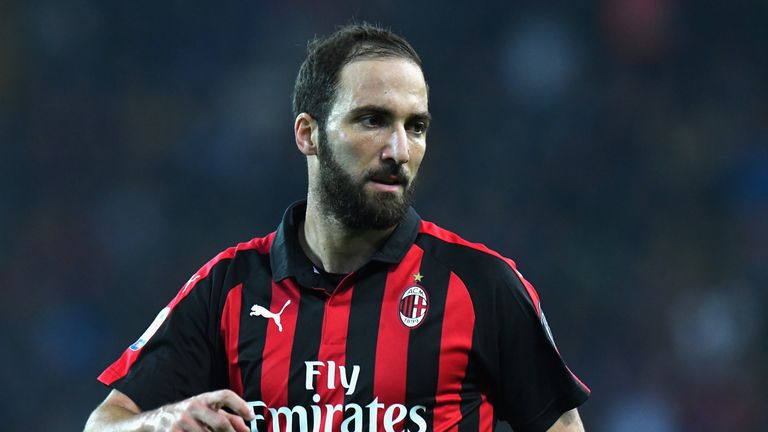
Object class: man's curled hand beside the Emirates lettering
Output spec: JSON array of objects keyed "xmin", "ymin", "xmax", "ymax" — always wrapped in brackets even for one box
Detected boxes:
[{"xmin": 150, "ymin": 390, "xmax": 254, "ymax": 432}]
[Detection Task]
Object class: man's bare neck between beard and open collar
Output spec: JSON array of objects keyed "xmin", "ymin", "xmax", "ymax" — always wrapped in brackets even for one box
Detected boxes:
[{"xmin": 299, "ymin": 196, "xmax": 395, "ymax": 274}]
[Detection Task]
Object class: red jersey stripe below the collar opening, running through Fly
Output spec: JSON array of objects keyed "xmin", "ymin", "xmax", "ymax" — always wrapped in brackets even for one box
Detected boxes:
[{"xmin": 317, "ymin": 277, "xmax": 354, "ymax": 431}]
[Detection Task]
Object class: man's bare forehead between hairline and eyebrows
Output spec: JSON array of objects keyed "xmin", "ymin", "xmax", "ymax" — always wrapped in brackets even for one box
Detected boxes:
[{"xmin": 332, "ymin": 58, "xmax": 428, "ymax": 113}]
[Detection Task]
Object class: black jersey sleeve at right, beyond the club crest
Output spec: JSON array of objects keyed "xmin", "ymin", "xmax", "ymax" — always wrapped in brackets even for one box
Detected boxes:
[{"xmin": 488, "ymin": 264, "xmax": 590, "ymax": 432}]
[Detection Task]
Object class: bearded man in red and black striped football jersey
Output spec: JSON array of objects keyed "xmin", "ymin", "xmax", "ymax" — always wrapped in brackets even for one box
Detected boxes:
[{"xmin": 86, "ymin": 25, "xmax": 589, "ymax": 432}]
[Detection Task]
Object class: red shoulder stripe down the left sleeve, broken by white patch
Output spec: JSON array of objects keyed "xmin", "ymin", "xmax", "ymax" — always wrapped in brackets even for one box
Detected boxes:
[{"xmin": 98, "ymin": 232, "xmax": 275, "ymax": 385}]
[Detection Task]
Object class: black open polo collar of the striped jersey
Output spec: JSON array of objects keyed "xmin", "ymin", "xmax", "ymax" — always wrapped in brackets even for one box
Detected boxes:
[{"xmin": 269, "ymin": 200, "xmax": 421, "ymax": 287}]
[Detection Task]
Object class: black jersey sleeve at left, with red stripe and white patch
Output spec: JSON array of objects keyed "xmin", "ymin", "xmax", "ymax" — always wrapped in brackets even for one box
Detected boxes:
[{"xmin": 98, "ymin": 255, "xmax": 232, "ymax": 411}]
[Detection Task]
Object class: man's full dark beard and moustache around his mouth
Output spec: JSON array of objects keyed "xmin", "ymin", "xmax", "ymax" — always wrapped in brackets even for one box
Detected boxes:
[{"xmin": 317, "ymin": 127, "xmax": 415, "ymax": 230}]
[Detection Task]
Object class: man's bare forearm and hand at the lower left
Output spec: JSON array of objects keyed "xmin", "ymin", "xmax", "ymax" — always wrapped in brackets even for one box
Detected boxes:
[{"xmin": 85, "ymin": 390, "xmax": 254, "ymax": 432}]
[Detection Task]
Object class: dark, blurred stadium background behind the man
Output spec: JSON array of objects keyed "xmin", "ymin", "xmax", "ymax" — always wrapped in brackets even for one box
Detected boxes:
[{"xmin": 0, "ymin": 0, "xmax": 768, "ymax": 432}]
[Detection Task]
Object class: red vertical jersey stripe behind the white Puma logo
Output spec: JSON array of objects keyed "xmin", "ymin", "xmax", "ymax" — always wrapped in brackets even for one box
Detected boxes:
[{"xmin": 260, "ymin": 279, "xmax": 301, "ymax": 430}]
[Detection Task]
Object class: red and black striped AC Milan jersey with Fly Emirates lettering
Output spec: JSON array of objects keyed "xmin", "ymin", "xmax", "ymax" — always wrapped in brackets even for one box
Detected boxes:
[{"xmin": 99, "ymin": 203, "xmax": 589, "ymax": 432}]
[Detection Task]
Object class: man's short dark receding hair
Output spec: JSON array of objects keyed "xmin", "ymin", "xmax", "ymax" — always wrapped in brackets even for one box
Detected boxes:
[{"xmin": 293, "ymin": 23, "xmax": 422, "ymax": 127}]
